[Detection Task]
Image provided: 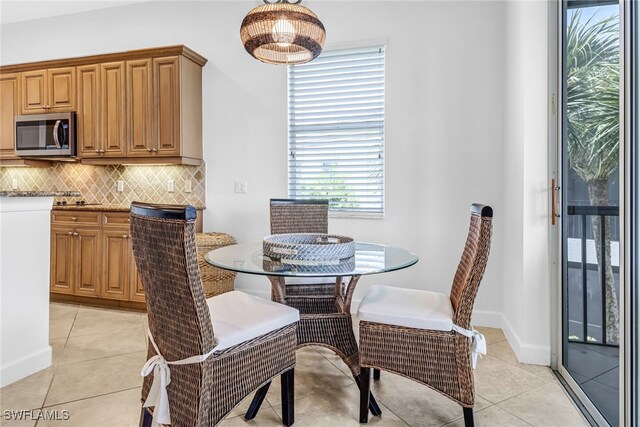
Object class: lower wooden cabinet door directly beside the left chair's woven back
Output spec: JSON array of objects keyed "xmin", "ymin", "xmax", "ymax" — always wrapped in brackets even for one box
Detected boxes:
[{"xmin": 101, "ymin": 227, "xmax": 131, "ymax": 301}]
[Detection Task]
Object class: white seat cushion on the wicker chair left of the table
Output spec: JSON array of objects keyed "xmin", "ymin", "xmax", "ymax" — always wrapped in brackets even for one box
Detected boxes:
[{"xmin": 207, "ymin": 291, "xmax": 300, "ymax": 351}]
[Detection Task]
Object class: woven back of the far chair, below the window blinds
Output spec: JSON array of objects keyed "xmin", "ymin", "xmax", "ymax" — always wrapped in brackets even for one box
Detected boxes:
[{"xmin": 269, "ymin": 199, "xmax": 329, "ymax": 234}]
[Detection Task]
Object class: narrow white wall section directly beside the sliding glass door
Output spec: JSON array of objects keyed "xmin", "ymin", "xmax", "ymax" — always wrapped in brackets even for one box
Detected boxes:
[{"xmin": 502, "ymin": 1, "xmax": 551, "ymax": 364}]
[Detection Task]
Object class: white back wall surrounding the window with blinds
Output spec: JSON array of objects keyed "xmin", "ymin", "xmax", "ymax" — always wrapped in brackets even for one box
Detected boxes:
[{"xmin": 0, "ymin": 1, "xmax": 546, "ymax": 366}]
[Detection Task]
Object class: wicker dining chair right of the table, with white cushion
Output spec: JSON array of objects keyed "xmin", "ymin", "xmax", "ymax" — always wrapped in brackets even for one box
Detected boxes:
[{"xmin": 358, "ymin": 204, "xmax": 493, "ymax": 426}]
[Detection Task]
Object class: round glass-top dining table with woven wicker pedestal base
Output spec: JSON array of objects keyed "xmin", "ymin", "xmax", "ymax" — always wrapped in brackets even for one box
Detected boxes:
[{"xmin": 205, "ymin": 242, "xmax": 418, "ymax": 419}]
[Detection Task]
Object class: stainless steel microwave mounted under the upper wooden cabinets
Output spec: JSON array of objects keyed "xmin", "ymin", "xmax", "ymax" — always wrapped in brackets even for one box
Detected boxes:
[{"xmin": 15, "ymin": 113, "xmax": 76, "ymax": 157}]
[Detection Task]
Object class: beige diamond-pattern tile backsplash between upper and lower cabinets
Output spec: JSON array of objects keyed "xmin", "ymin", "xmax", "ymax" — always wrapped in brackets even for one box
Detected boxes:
[{"xmin": 0, "ymin": 163, "xmax": 206, "ymax": 207}]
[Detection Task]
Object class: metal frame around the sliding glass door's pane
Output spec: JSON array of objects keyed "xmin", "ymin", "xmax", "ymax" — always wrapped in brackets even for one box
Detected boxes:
[{"xmin": 548, "ymin": 0, "xmax": 624, "ymax": 426}]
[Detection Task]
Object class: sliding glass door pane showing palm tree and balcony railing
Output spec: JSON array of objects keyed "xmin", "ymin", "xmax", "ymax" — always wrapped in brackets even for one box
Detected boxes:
[{"xmin": 559, "ymin": 0, "xmax": 621, "ymax": 426}]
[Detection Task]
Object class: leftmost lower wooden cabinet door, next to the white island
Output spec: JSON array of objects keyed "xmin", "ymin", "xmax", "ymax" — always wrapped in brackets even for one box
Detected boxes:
[{"xmin": 49, "ymin": 227, "xmax": 75, "ymax": 294}]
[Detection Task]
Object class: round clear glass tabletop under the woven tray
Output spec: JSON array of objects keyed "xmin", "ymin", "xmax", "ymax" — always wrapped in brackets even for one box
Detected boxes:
[{"xmin": 205, "ymin": 242, "xmax": 418, "ymax": 277}]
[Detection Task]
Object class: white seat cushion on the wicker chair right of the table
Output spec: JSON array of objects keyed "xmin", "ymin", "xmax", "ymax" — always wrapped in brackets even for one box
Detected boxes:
[{"xmin": 358, "ymin": 285, "xmax": 453, "ymax": 331}]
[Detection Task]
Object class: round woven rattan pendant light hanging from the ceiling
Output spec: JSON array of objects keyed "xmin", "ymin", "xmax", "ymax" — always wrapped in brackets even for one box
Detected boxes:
[{"xmin": 240, "ymin": 0, "xmax": 325, "ymax": 65}]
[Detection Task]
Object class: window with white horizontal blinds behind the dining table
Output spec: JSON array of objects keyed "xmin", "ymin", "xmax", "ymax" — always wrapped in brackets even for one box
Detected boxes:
[{"xmin": 288, "ymin": 46, "xmax": 384, "ymax": 216}]
